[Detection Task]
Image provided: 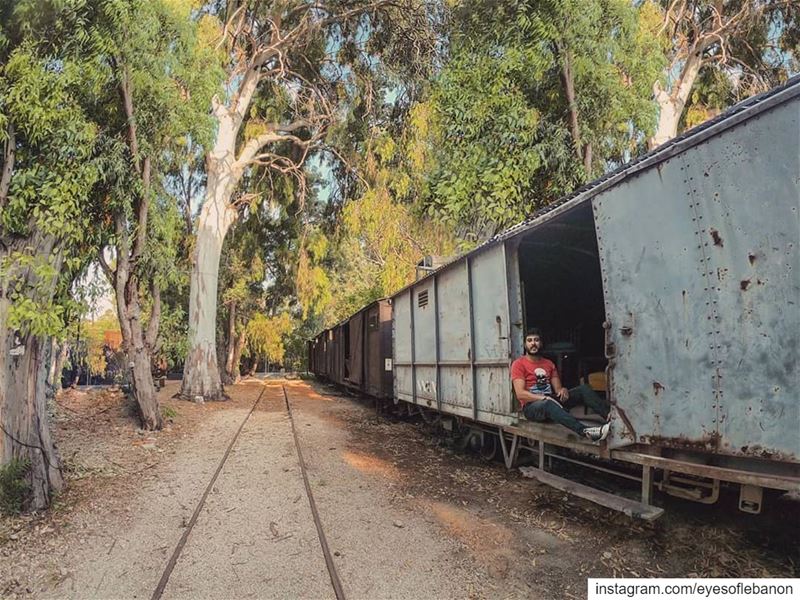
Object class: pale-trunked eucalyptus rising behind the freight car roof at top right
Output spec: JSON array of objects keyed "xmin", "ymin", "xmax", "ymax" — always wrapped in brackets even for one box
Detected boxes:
[{"xmin": 648, "ymin": 0, "xmax": 800, "ymax": 148}]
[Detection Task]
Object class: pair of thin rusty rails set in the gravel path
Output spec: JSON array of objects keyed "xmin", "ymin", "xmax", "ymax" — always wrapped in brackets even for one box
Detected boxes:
[{"xmin": 151, "ymin": 386, "xmax": 345, "ymax": 600}]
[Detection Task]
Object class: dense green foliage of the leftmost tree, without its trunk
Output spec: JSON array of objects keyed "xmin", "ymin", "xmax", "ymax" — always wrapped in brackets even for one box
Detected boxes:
[{"xmin": 0, "ymin": 0, "xmax": 102, "ymax": 335}]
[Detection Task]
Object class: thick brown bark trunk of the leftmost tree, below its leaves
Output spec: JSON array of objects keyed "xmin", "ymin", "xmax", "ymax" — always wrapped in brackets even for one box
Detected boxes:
[{"xmin": 0, "ymin": 236, "xmax": 64, "ymax": 510}]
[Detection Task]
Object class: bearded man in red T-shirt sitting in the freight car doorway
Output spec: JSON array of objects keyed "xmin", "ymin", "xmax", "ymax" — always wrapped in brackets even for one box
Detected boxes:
[{"xmin": 511, "ymin": 328, "xmax": 610, "ymax": 441}]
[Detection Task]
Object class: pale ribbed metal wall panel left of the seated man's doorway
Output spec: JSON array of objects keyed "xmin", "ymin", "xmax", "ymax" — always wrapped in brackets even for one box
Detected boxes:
[{"xmin": 392, "ymin": 244, "xmax": 519, "ymax": 422}]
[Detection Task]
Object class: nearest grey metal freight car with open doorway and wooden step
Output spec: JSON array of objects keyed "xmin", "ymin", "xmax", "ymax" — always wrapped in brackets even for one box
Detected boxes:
[{"xmin": 310, "ymin": 78, "xmax": 800, "ymax": 518}]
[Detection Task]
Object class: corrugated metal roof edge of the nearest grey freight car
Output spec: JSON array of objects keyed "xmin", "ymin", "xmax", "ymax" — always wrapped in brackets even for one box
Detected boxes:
[{"xmin": 391, "ymin": 75, "xmax": 800, "ymax": 298}]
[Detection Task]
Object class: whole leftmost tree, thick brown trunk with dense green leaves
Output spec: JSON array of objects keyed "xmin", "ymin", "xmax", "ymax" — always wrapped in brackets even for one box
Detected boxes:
[{"xmin": 0, "ymin": 0, "xmax": 102, "ymax": 509}]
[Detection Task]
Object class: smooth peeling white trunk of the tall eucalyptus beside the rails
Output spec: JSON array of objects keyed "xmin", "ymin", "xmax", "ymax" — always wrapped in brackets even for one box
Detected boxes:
[{"xmin": 180, "ymin": 114, "xmax": 240, "ymax": 400}]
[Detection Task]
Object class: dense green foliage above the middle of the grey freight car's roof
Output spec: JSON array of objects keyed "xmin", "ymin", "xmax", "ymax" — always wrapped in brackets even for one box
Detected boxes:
[{"xmin": 412, "ymin": 0, "xmax": 663, "ymax": 238}]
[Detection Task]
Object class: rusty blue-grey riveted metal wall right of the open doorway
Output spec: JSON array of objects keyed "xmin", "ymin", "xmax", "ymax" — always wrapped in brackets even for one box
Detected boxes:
[{"xmin": 592, "ymin": 99, "xmax": 800, "ymax": 461}]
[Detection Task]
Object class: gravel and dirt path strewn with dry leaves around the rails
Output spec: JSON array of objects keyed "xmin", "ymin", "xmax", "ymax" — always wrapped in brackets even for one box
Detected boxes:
[{"xmin": 0, "ymin": 381, "xmax": 800, "ymax": 599}]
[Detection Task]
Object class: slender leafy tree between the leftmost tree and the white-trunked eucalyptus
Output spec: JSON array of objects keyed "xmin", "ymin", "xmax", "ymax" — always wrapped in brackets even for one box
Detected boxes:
[{"xmin": 93, "ymin": 0, "xmax": 220, "ymax": 429}]
